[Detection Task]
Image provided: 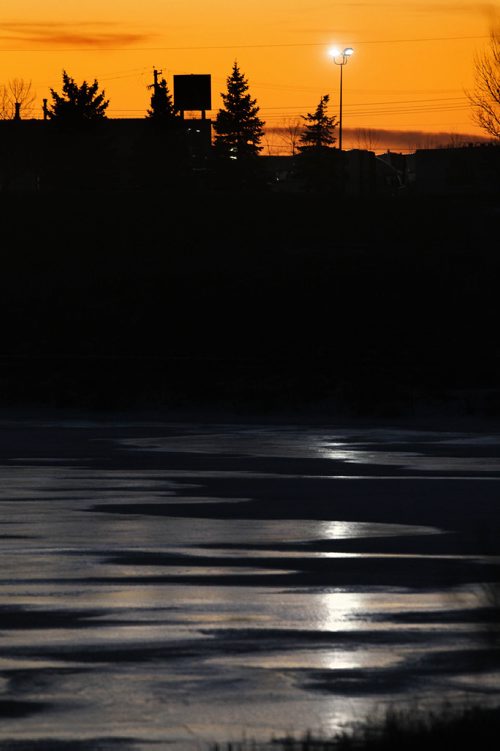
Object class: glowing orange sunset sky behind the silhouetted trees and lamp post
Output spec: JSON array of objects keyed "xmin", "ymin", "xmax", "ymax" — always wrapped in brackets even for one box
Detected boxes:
[{"xmin": 0, "ymin": 0, "xmax": 500, "ymax": 149}]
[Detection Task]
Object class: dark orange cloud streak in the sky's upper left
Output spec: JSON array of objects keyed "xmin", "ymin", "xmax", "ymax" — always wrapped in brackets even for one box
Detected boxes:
[{"xmin": 0, "ymin": 21, "xmax": 153, "ymax": 49}]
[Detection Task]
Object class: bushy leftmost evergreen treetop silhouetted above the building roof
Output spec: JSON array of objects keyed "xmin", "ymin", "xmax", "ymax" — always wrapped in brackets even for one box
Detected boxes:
[{"xmin": 48, "ymin": 71, "xmax": 109, "ymax": 127}]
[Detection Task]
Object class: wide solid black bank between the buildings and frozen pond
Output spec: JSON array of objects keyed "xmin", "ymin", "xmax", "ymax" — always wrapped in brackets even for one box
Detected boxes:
[{"xmin": 0, "ymin": 185, "xmax": 500, "ymax": 416}]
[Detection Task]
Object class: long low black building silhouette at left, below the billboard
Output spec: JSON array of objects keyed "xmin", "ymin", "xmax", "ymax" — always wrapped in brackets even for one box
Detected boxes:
[{"xmin": 0, "ymin": 117, "xmax": 212, "ymax": 191}]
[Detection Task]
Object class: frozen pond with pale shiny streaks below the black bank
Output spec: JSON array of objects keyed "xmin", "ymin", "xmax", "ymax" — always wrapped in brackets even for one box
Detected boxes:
[{"xmin": 0, "ymin": 417, "xmax": 500, "ymax": 751}]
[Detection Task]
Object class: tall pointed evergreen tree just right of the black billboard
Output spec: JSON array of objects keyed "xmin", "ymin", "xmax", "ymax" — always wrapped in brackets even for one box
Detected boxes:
[{"xmin": 214, "ymin": 62, "xmax": 265, "ymax": 159}]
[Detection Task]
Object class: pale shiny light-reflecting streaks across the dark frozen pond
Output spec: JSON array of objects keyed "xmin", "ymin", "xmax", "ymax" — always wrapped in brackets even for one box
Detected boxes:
[{"xmin": 0, "ymin": 421, "xmax": 500, "ymax": 751}]
